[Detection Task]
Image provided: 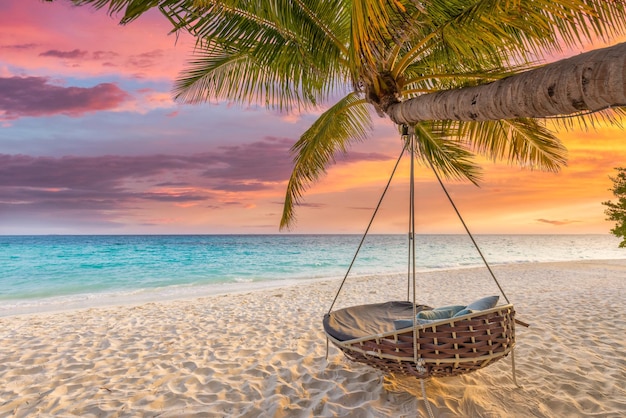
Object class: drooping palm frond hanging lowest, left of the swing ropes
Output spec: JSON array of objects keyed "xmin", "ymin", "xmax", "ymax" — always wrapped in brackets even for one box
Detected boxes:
[{"xmin": 280, "ymin": 93, "xmax": 371, "ymax": 229}]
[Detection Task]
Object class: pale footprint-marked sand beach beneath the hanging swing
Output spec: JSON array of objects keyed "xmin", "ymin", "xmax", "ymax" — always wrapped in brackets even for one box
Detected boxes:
[{"xmin": 0, "ymin": 260, "xmax": 626, "ymax": 418}]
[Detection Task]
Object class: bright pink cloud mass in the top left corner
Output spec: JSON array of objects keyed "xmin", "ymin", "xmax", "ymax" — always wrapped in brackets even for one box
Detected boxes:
[{"xmin": 0, "ymin": 0, "xmax": 194, "ymax": 80}]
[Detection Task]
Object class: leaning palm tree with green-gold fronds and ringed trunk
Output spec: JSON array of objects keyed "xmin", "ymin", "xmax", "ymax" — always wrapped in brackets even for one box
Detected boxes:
[{"xmin": 58, "ymin": 0, "xmax": 626, "ymax": 228}]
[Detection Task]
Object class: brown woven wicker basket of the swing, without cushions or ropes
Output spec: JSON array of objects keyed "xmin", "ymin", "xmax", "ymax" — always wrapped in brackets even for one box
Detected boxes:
[{"xmin": 326, "ymin": 304, "xmax": 515, "ymax": 379}]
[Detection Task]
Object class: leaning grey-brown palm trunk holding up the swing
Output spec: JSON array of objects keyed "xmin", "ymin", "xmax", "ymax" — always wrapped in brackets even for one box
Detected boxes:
[{"xmin": 387, "ymin": 43, "xmax": 626, "ymax": 125}]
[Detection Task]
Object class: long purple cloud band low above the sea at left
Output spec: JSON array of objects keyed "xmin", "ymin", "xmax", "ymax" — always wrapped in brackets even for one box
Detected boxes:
[{"xmin": 0, "ymin": 137, "xmax": 390, "ymax": 214}]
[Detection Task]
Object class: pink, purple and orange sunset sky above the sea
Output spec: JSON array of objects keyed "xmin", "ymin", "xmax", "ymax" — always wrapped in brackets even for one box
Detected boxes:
[{"xmin": 0, "ymin": 0, "xmax": 626, "ymax": 234}]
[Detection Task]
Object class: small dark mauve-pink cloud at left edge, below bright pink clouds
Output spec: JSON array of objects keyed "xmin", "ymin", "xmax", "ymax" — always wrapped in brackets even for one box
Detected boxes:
[{"xmin": 0, "ymin": 77, "xmax": 130, "ymax": 121}]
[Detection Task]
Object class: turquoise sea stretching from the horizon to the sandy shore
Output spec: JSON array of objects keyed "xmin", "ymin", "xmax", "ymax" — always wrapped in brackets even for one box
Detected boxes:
[{"xmin": 0, "ymin": 234, "xmax": 626, "ymax": 316}]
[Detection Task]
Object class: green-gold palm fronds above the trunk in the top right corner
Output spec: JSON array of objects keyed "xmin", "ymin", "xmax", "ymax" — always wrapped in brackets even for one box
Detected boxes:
[{"xmin": 393, "ymin": 0, "xmax": 626, "ymax": 84}]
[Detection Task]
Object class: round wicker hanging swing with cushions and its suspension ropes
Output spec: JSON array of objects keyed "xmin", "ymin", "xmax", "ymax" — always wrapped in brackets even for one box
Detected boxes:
[{"xmin": 323, "ymin": 126, "xmax": 526, "ymax": 380}]
